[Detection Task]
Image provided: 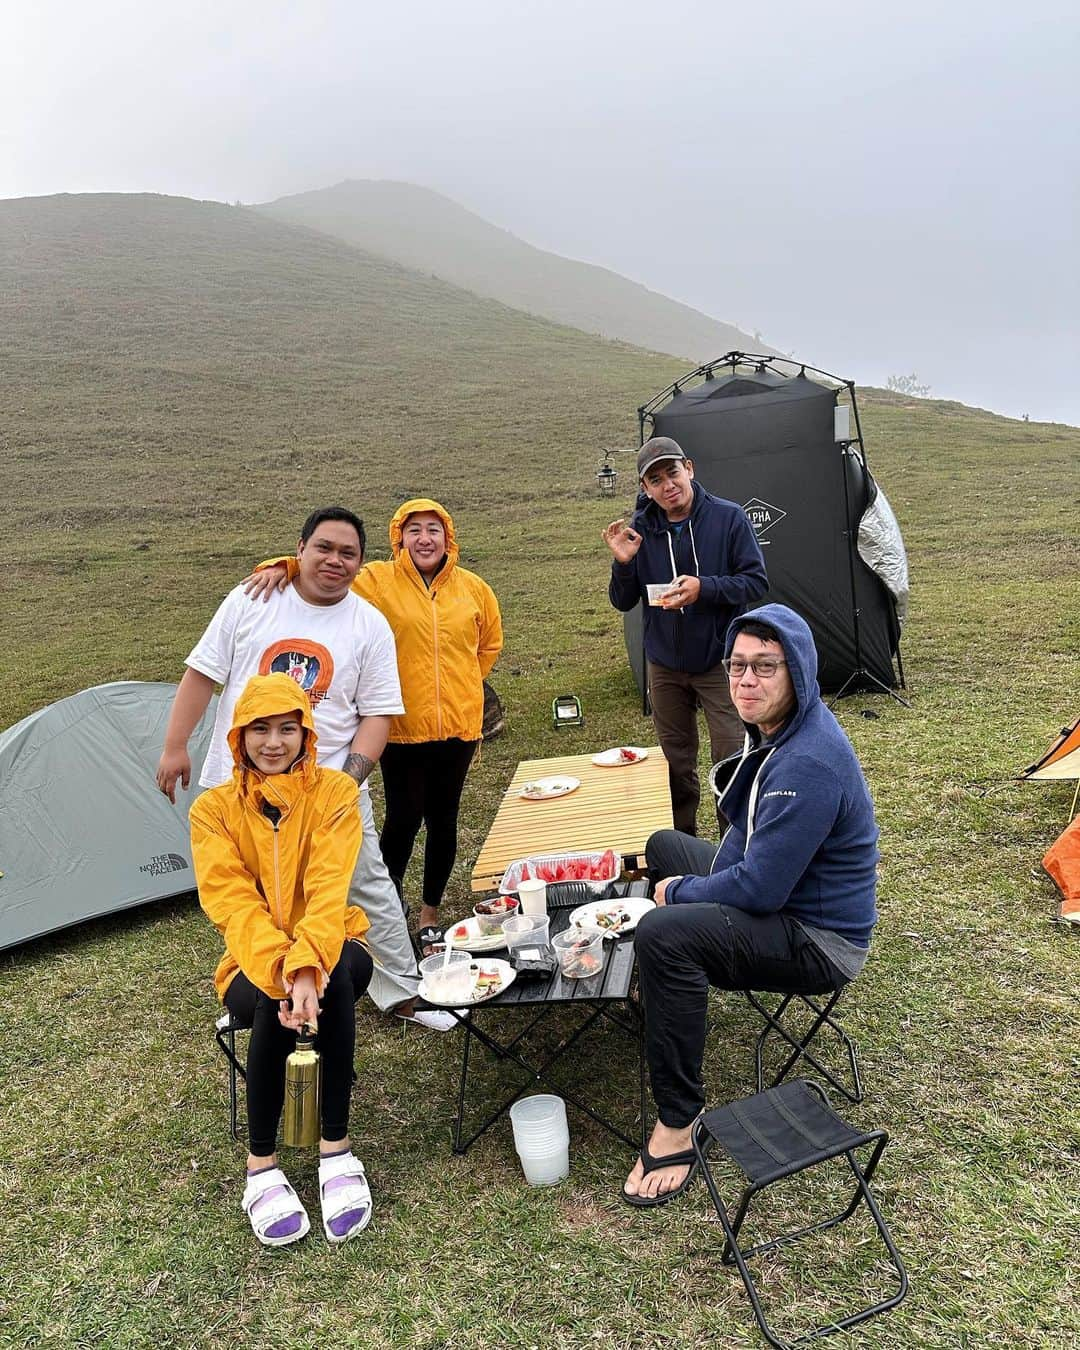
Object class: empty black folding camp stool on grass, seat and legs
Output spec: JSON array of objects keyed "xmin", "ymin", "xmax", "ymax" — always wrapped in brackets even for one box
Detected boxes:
[{"xmin": 693, "ymin": 1079, "xmax": 907, "ymax": 1350}]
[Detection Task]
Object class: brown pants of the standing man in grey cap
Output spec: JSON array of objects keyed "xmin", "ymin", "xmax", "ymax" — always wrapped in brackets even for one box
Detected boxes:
[{"xmin": 645, "ymin": 662, "xmax": 745, "ymax": 834}]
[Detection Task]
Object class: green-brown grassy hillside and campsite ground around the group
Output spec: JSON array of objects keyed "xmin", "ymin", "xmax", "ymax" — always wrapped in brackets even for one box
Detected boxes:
[{"xmin": 0, "ymin": 196, "xmax": 1080, "ymax": 1350}]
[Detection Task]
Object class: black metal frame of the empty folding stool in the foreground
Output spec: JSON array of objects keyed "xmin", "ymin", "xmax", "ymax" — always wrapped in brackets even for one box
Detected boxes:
[{"xmin": 693, "ymin": 1080, "xmax": 909, "ymax": 1350}]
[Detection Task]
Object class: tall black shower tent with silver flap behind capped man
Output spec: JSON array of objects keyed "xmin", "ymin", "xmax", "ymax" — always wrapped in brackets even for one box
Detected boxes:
[{"xmin": 626, "ymin": 352, "xmax": 907, "ymax": 691}]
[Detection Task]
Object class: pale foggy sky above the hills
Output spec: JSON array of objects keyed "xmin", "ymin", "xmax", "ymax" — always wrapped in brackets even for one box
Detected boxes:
[{"xmin": 0, "ymin": 0, "xmax": 1080, "ymax": 424}]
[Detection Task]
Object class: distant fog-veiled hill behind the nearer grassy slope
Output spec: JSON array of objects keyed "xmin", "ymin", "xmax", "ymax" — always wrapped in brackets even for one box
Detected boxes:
[{"xmin": 259, "ymin": 181, "xmax": 775, "ymax": 362}]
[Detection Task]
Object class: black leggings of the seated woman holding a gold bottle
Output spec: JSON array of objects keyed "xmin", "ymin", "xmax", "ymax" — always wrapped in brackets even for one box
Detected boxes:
[{"xmin": 225, "ymin": 942, "xmax": 371, "ymax": 1158}]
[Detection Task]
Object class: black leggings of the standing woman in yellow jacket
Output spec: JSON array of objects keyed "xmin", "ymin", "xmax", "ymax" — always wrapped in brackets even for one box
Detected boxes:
[{"xmin": 379, "ymin": 738, "xmax": 478, "ymax": 906}]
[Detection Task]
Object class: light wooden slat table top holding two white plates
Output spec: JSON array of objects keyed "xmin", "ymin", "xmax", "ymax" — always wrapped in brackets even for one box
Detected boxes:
[{"xmin": 473, "ymin": 745, "xmax": 672, "ymax": 891}]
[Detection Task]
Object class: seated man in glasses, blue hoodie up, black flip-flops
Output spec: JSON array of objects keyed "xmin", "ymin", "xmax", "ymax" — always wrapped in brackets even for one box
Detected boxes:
[{"xmin": 622, "ymin": 605, "xmax": 878, "ymax": 1206}]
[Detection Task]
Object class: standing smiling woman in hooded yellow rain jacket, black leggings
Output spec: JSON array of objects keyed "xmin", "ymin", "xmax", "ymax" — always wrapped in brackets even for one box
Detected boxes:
[{"xmin": 352, "ymin": 497, "xmax": 502, "ymax": 950}]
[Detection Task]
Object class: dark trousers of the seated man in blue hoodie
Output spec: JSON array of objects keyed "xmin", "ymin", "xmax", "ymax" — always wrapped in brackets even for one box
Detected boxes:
[{"xmin": 635, "ymin": 830, "xmax": 846, "ymax": 1129}]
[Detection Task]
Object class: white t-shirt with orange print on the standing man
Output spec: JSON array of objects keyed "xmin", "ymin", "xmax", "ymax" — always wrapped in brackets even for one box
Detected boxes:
[{"xmin": 186, "ymin": 586, "xmax": 405, "ymax": 787}]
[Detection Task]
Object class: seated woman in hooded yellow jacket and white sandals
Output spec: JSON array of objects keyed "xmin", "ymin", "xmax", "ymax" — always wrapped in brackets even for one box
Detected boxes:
[{"xmin": 190, "ymin": 675, "xmax": 371, "ymax": 1246}]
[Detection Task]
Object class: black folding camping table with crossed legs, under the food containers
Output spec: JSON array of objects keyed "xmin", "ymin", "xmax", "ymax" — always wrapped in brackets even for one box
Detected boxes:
[{"xmin": 454, "ymin": 883, "xmax": 648, "ymax": 1153}]
